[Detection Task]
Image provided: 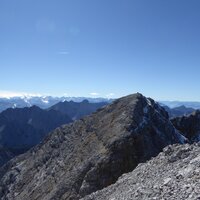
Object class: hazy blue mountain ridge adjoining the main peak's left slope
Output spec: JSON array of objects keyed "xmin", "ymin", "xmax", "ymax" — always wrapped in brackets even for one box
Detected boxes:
[{"xmin": 48, "ymin": 100, "xmax": 108, "ymax": 120}]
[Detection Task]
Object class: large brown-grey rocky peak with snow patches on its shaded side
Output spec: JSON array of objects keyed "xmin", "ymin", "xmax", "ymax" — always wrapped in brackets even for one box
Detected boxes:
[{"xmin": 0, "ymin": 94, "xmax": 185, "ymax": 200}]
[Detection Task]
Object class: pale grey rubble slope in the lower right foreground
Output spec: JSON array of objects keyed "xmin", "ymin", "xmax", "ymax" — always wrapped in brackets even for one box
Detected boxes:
[{"xmin": 82, "ymin": 144, "xmax": 200, "ymax": 200}]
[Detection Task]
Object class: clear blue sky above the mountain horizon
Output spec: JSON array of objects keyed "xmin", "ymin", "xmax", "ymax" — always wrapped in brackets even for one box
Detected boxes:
[{"xmin": 0, "ymin": 0, "xmax": 200, "ymax": 101}]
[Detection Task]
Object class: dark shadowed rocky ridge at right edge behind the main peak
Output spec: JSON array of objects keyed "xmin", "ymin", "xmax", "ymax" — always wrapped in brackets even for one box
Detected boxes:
[{"xmin": 171, "ymin": 110, "xmax": 200, "ymax": 142}]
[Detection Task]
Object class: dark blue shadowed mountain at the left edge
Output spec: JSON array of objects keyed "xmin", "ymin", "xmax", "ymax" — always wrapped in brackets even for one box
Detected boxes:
[{"xmin": 0, "ymin": 106, "xmax": 72, "ymax": 166}]
